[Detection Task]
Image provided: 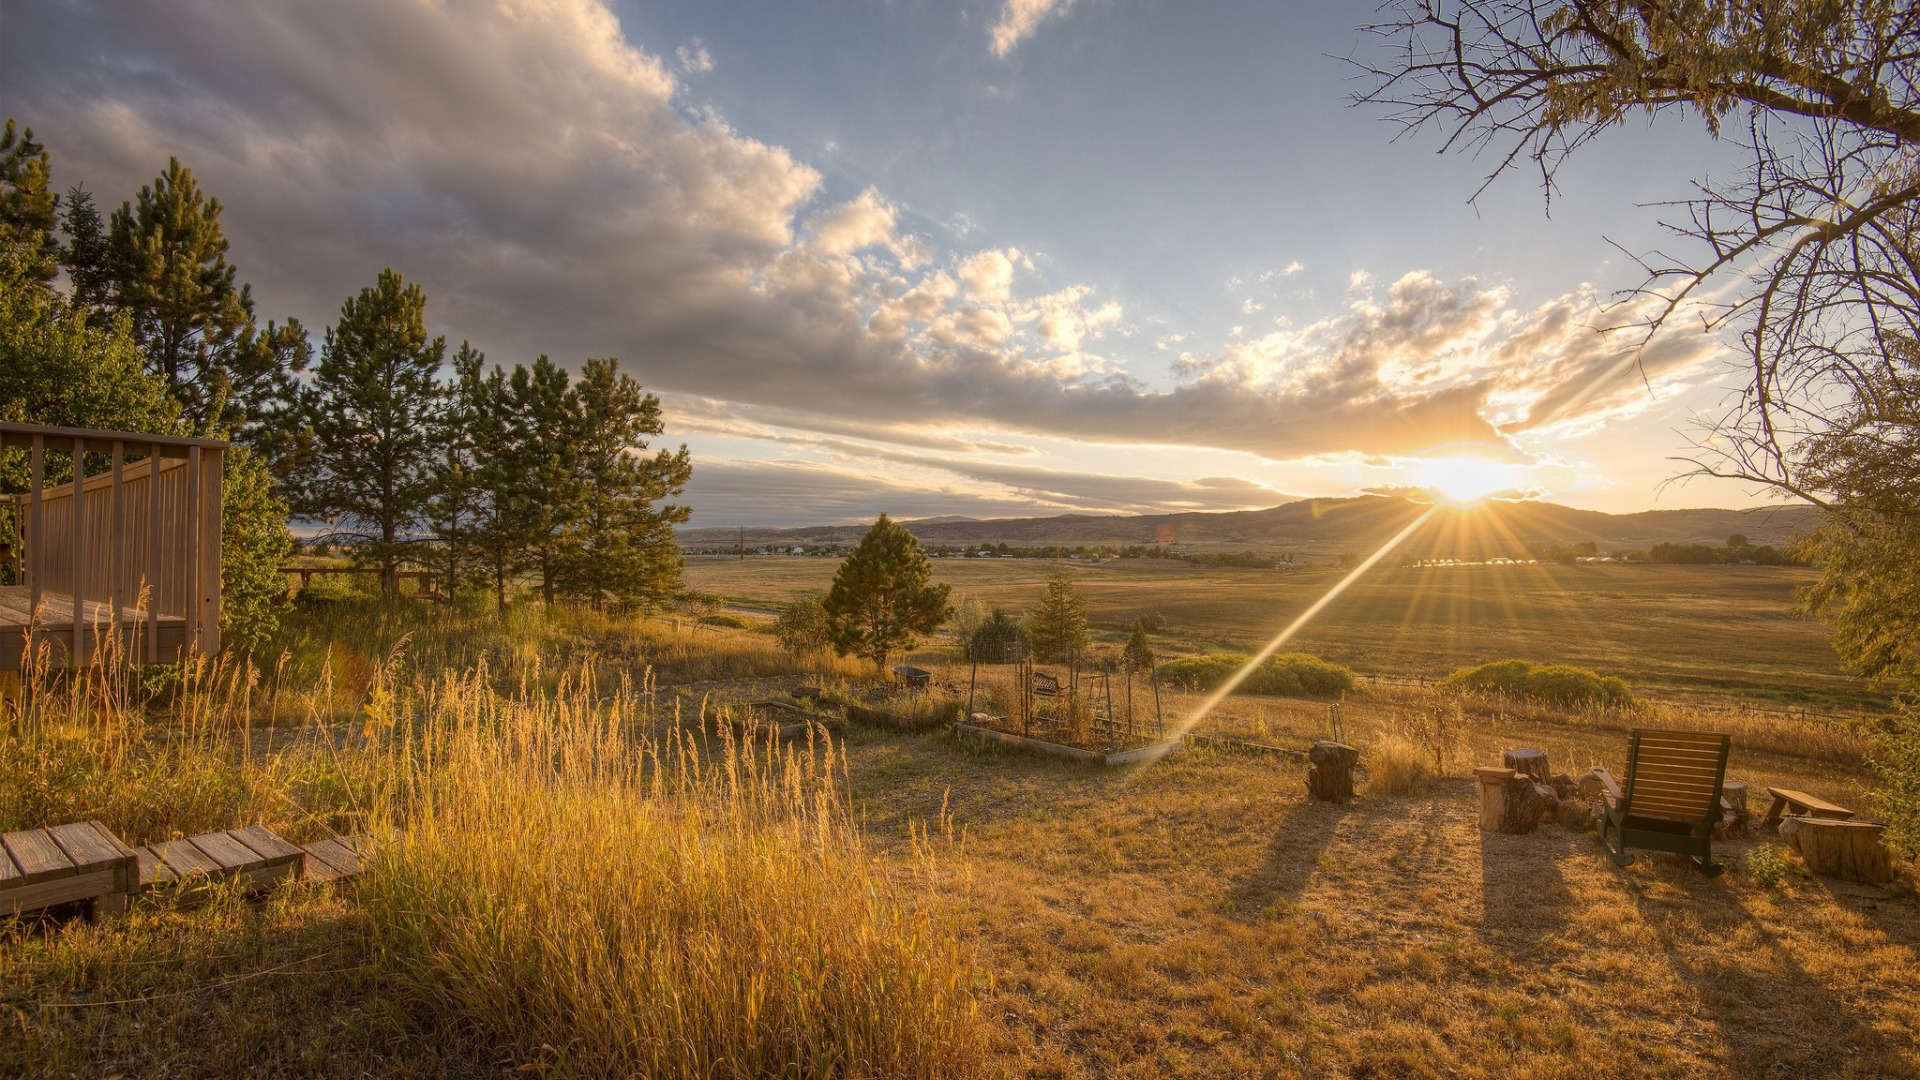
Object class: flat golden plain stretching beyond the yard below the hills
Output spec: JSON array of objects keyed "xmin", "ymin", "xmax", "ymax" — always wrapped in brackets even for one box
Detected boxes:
[{"xmin": 687, "ymin": 557, "xmax": 1885, "ymax": 707}]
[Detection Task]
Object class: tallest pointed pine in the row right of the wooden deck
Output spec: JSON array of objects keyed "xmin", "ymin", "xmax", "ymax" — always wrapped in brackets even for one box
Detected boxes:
[{"xmin": 296, "ymin": 267, "xmax": 447, "ymax": 598}]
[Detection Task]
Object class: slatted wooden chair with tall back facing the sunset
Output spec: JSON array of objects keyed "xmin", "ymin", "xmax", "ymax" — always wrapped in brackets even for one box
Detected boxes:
[{"xmin": 1594, "ymin": 728, "xmax": 1734, "ymax": 878}]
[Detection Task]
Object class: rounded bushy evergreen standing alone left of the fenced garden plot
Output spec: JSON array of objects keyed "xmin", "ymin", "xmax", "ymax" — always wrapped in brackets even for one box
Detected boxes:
[{"xmin": 824, "ymin": 513, "xmax": 952, "ymax": 667}]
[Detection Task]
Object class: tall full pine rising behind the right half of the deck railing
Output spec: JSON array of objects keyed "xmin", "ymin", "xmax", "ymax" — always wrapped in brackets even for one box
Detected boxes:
[{"xmin": 102, "ymin": 158, "xmax": 309, "ymax": 441}]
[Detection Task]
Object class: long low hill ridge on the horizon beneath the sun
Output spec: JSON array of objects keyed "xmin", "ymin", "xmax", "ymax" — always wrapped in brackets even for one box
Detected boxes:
[{"xmin": 680, "ymin": 496, "xmax": 1814, "ymax": 557}]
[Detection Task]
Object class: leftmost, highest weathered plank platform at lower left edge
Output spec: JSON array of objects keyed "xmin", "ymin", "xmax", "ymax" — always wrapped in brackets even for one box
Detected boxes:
[{"xmin": 0, "ymin": 821, "xmax": 138, "ymax": 915}]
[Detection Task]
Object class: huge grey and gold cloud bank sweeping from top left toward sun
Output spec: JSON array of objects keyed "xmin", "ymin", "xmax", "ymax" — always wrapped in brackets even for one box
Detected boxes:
[{"xmin": 0, "ymin": 0, "xmax": 1709, "ymax": 478}]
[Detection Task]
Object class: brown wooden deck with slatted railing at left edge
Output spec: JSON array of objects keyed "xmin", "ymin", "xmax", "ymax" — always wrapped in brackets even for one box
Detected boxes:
[{"xmin": 0, "ymin": 423, "xmax": 227, "ymax": 669}]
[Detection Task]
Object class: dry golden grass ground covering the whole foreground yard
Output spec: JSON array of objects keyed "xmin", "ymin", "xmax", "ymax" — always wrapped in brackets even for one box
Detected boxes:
[{"xmin": 0, "ymin": 607, "xmax": 1920, "ymax": 1080}]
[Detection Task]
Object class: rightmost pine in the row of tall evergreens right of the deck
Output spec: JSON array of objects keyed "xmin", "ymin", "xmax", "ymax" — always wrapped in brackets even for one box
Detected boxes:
[{"xmin": 564, "ymin": 359, "xmax": 693, "ymax": 607}]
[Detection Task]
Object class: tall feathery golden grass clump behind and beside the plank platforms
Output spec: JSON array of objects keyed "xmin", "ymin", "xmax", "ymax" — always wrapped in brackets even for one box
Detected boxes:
[{"xmin": 0, "ymin": 611, "xmax": 989, "ymax": 1078}]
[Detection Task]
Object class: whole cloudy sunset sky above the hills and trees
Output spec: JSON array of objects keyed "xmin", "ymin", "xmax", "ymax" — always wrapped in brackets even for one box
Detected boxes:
[{"xmin": 0, "ymin": 0, "xmax": 1761, "ymax": 527}]
